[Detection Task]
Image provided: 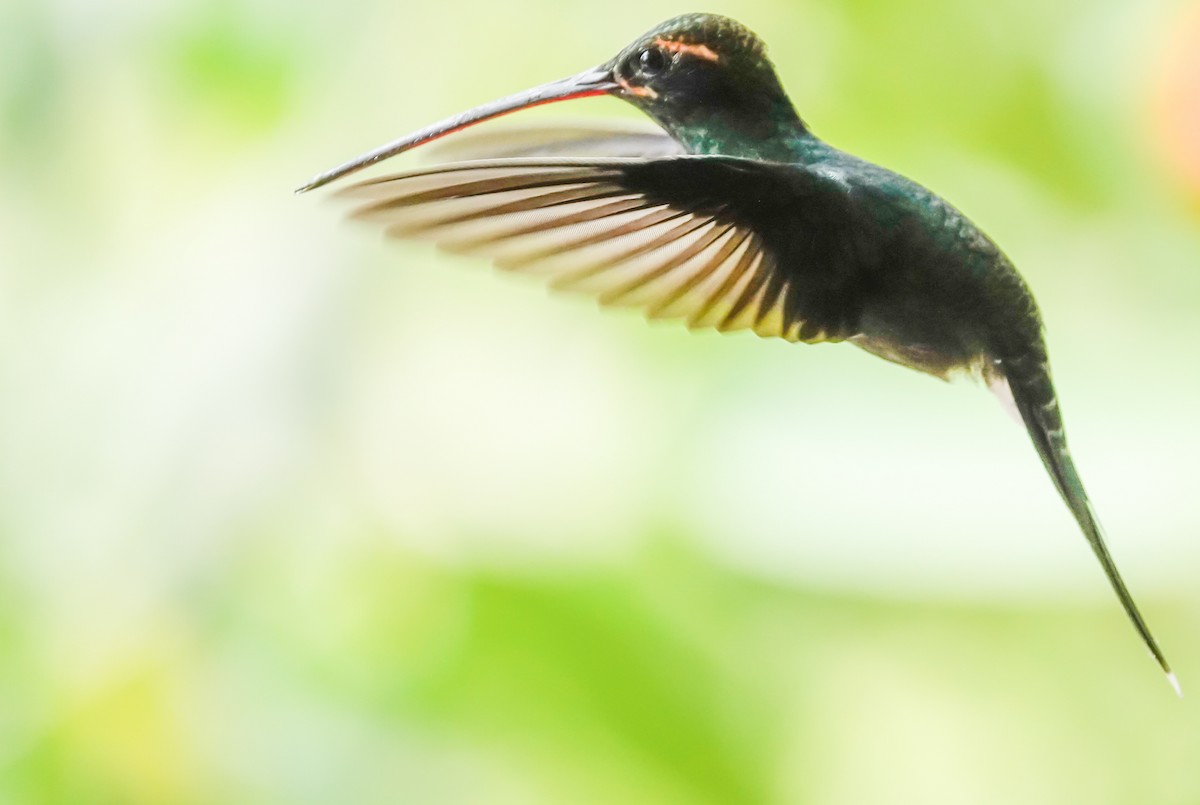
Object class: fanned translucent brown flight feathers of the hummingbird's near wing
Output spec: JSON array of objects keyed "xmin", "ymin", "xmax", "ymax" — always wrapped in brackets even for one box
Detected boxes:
[{"xmin": 341, "ymin": 157, "xmax": 824, "ymax": 341}]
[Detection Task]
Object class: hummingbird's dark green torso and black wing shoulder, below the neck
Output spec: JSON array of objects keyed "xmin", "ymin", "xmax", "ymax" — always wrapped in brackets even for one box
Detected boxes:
[{"xmin": 609, "ymin": 148, "xmax": 1040, "ymax": 369}]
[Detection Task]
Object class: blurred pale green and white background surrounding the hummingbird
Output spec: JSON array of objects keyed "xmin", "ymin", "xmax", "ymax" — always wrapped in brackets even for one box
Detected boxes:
[{"xmin": 0, "ymin": 0, "xmax": 1200, "ymax": 805}]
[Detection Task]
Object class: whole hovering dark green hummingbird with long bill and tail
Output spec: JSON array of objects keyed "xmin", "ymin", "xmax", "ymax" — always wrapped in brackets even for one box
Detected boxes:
[{"xmin": 296, "ymin": 14, "xmax": 1180, "ymax": 693}]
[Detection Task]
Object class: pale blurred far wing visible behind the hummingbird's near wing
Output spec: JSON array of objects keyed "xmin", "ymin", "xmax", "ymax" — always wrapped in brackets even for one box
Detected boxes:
[{"xmin": 421, "ymin": 125, "xmax": 684, "ymax": 162}]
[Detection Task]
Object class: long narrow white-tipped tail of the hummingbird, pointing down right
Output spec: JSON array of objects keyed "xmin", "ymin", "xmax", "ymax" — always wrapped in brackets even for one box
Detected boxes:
[{"xmin": 1001, "ymin": 359, "xmax": 1182, "ymax": 696}]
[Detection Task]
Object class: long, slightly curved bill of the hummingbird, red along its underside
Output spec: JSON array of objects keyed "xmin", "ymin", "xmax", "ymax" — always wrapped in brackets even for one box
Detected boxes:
[{"xmin": 296, "ymin": 67, "xmax": 617, "ymax": 193}]
